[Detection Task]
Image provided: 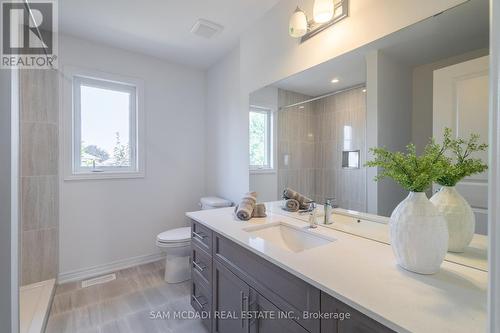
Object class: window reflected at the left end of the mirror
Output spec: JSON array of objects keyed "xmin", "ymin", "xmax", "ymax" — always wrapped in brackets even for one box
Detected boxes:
[{"xmin": 249, "ymin": 108, "xmax": 273, "ymax": 170}]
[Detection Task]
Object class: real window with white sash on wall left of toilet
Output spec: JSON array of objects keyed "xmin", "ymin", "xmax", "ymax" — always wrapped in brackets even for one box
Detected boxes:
[{"xmin": 72, "ymin": 76, "xmax": 138, "ymax": 175}]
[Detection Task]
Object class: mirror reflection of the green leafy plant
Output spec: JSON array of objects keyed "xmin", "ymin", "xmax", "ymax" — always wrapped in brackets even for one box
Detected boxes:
[{"xmin": 436, "ymin": 128, "xmax": 488, "ymax": 186}]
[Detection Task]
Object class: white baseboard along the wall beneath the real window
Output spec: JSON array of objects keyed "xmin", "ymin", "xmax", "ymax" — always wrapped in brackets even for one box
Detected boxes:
[{"xmin": 57, "ymin": 253, "xmax": 165, "ymax": 284}]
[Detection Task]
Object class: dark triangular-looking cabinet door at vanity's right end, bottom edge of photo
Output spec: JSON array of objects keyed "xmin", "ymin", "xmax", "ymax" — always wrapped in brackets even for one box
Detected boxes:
[{"xmin": 321, "ymin": 293, "xmax": 394, "ymax": 333}]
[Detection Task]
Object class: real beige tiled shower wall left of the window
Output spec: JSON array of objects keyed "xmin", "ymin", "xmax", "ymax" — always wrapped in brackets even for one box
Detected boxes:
[{"xmin": 20, "ymin": 69, "xmax": 59, "ymax": 285}]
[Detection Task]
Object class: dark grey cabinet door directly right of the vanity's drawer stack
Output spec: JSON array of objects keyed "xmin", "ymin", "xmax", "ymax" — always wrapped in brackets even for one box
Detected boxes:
[{"xmin": 213, "ymin": 260, "xmax": 250, "ymax": 333}]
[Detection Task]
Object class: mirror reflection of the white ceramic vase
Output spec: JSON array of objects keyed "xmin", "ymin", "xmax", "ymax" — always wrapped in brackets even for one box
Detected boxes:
[{"xmin": 431, "ymin": 186, "xmax": 476, "ymax": 252}]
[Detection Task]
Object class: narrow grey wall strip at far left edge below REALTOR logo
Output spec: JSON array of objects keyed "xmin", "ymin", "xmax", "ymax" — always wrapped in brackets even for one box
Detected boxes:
[{"xmin": 0, "ymin": 69, "xmax": 17, "ymax": 332}]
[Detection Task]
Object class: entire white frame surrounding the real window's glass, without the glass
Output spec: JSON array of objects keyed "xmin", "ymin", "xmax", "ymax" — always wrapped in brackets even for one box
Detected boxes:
[{"xmin": 60, "ymin": 66, "xmax": 146, "ymax": 181}]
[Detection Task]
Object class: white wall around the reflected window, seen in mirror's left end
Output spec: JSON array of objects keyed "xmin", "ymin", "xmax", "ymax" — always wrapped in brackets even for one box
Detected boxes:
[{"xmin": 249, "ymin": 86, "xmax": 279, "ymax": 201}]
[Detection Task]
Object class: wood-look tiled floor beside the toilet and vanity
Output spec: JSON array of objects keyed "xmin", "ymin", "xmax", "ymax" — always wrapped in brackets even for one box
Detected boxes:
[{"xmin": 46, "ymin": 261, "xmax": 195, "ymax": 333}]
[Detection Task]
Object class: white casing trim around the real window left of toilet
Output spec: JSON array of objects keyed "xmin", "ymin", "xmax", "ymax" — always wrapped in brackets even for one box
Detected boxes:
[{"xmin": 60, "ymin": 66, "xmax": 146, "ymax": 180}]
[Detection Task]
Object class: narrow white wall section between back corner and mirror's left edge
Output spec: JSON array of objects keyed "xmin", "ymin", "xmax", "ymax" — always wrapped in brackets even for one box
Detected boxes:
[{"xmin": 205, "ymin": 48, "xmax": 249, "ymax": 202}]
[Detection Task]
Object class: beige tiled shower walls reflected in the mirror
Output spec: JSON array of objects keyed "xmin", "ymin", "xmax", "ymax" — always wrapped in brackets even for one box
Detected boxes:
[{"xmin": 278, "ymin": 88, "xmax": 366, "ymax": 211}]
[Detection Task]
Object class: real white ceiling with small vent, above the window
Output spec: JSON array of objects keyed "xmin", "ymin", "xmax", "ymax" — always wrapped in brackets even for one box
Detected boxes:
[{"xmin": 59, "ymin": 0, "xmax": 279, "ymax": 68}]
